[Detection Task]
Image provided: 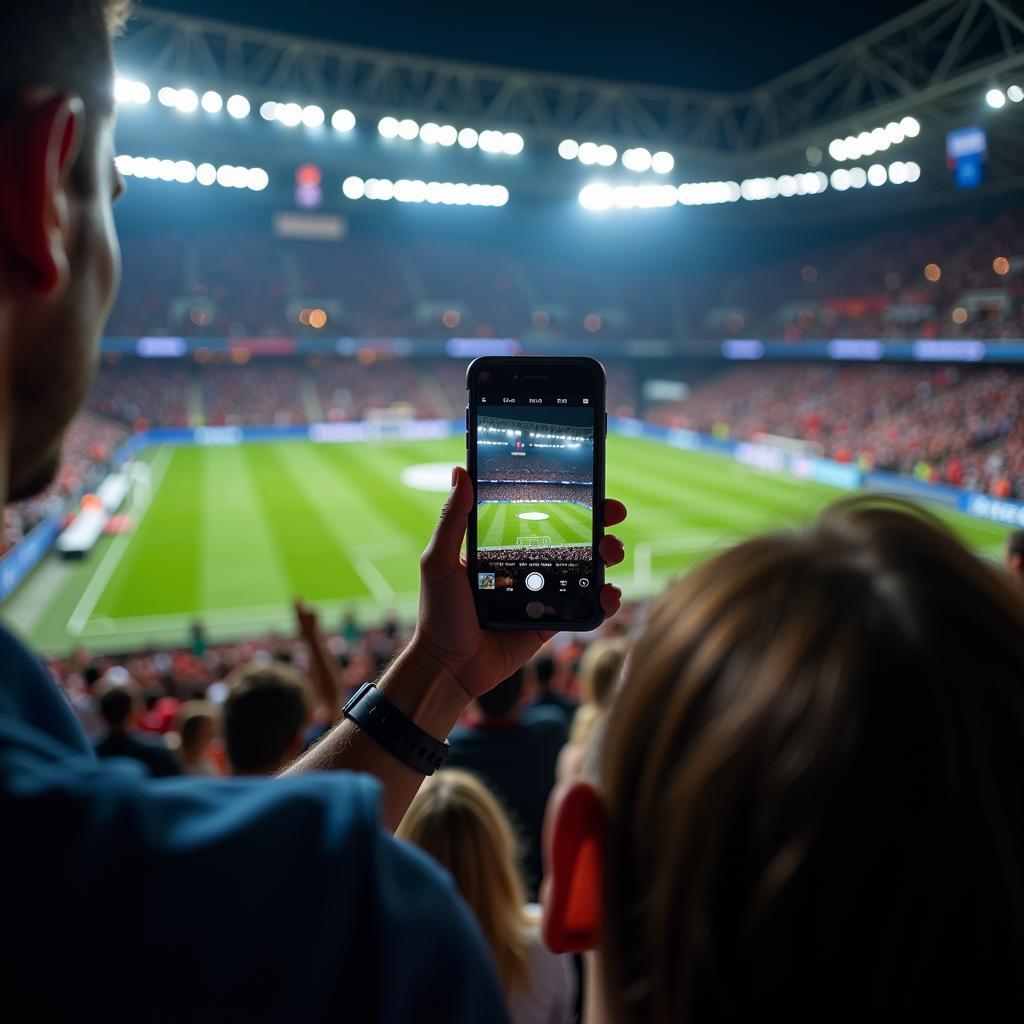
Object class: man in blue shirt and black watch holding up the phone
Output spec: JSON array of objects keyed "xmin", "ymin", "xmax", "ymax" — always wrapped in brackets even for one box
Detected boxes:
[{"xmin": 0, "ymin": 0, "xmax": 626, "ymax": 1024}]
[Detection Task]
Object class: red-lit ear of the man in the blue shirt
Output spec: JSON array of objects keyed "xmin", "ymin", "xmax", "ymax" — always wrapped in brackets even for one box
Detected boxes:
[{"xmin": 0, "ymin": 93, "xmax": 85, "ymax": 296}]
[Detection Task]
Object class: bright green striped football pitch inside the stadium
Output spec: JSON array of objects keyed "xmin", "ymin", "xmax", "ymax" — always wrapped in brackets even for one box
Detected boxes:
[{"xmin": 0, "ymin": 436, "xmax": 1007, "ymax": 653}]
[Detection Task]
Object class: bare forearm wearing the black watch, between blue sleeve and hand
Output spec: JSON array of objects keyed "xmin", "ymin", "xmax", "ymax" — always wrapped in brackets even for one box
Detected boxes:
[{"xmin": 284, "ymin": 640, "xmax": 469, "ymax": 829}]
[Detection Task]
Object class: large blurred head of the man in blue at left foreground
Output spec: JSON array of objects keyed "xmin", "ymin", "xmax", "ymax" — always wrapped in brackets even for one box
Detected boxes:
[{"xmin": 0, "ymin": 0, "xmax": 129, "ymax": 498}]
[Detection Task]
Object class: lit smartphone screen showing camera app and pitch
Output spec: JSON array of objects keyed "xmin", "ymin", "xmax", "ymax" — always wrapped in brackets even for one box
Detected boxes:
[{"xmin": 476, "ymin": 394, "xmax": 594, "ymax": 598}]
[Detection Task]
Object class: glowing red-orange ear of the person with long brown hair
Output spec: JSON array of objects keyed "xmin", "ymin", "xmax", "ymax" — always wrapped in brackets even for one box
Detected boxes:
[{"xmin": 541, "ymin": 779, "xmax": 605, "ymax": 953}]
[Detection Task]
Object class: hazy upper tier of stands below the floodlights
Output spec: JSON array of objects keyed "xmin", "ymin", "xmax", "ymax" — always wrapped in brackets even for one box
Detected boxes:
[{"xmin": 108, "ymin": 210, "xmax": 1024, "ymax": 344}]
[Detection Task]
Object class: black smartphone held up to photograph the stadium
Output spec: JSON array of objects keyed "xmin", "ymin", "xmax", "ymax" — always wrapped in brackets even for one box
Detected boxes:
[{"xmin": 466, "ymin": 356, "xmax": 607, "ymax": 631}]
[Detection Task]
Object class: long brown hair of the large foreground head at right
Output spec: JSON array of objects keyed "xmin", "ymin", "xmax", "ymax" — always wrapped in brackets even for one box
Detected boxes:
[{"xmin": 600, "ymin": 499, "xmax": 1024, "ymax": 1022}]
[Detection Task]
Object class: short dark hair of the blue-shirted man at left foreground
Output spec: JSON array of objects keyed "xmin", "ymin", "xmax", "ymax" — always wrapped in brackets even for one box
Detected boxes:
[{"xmin": 0, "ymin": 0, "xmax": 131, "ymax": 186}]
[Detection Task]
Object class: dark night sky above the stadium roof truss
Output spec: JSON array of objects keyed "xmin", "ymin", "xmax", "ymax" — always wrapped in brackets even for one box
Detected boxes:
[{"xmin": 142, "ymin": 0, "xmax": 916, "ymax": 90}]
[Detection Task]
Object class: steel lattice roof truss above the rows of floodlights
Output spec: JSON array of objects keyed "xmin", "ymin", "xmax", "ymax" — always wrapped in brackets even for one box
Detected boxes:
[{"xmin": 119, "ymin": 0, "xmax": 1024, "ymax": 170}]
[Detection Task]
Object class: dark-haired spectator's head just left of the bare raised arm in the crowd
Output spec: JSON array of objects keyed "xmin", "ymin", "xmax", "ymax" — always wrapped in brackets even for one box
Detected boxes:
[{"xmin": 223, "ymin": 662, "xmax": 309, "ymax": 775}]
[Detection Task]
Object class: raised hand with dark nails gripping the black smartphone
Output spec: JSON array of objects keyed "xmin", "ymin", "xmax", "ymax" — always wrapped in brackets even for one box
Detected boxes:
[{"xmin": 411, "ymin": 467, "xmax": 626, "ymax": 701}]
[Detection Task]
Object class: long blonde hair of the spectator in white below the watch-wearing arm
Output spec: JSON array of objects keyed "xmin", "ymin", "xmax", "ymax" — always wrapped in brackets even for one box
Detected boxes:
[{"xmin": 395, "ymin": 768, "xmax": 530, "ymax": 997}]
